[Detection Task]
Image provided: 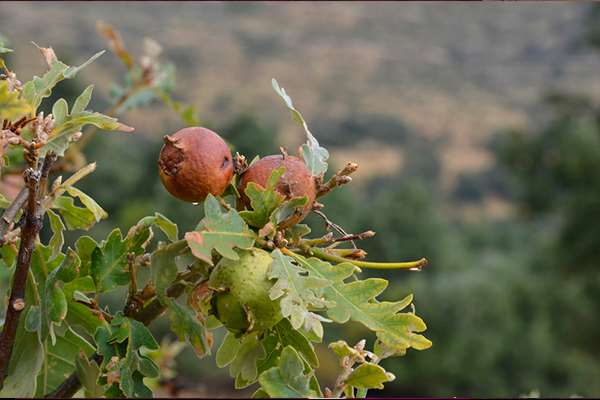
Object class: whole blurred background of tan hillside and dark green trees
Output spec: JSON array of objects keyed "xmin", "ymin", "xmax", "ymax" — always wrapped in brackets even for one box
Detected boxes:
[{"xmin": 0, "ymin": 2, "xmax": 600, "ymax": 397}]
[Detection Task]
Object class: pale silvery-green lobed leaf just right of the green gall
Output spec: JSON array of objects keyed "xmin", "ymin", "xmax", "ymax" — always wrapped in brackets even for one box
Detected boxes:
[{"xmin": 268, "ymin": 249, "xmax": 333, "ymax": 329}]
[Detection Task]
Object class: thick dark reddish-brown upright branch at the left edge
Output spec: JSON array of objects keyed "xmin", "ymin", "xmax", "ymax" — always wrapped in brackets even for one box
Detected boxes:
[{"xmin": 0, "ymin": 154, "xmax": 56, "ymax": 387}]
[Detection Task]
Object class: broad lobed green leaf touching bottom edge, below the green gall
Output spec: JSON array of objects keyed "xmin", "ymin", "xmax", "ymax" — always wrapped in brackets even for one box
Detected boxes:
[{"xmin": 258, "ymin": 346, "xmax": 317, "ymax": 398}]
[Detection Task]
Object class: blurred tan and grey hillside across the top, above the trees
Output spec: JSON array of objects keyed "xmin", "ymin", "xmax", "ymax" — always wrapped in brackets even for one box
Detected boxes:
[{"xmin": 0, "ymin": 2, "xmax": 600, "ymax": 189}]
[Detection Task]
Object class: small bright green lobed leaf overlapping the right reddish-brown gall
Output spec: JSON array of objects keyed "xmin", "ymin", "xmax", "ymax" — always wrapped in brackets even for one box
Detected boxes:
[{"xmin": 240, "ymin": 166, "xmax": 285, "ymax": 228}]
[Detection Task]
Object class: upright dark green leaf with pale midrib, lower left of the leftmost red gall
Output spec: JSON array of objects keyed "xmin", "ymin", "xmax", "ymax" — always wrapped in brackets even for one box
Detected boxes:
[{"xmin": 90, "ymin": 228, "xmax": 129, "ymax": 292}]
